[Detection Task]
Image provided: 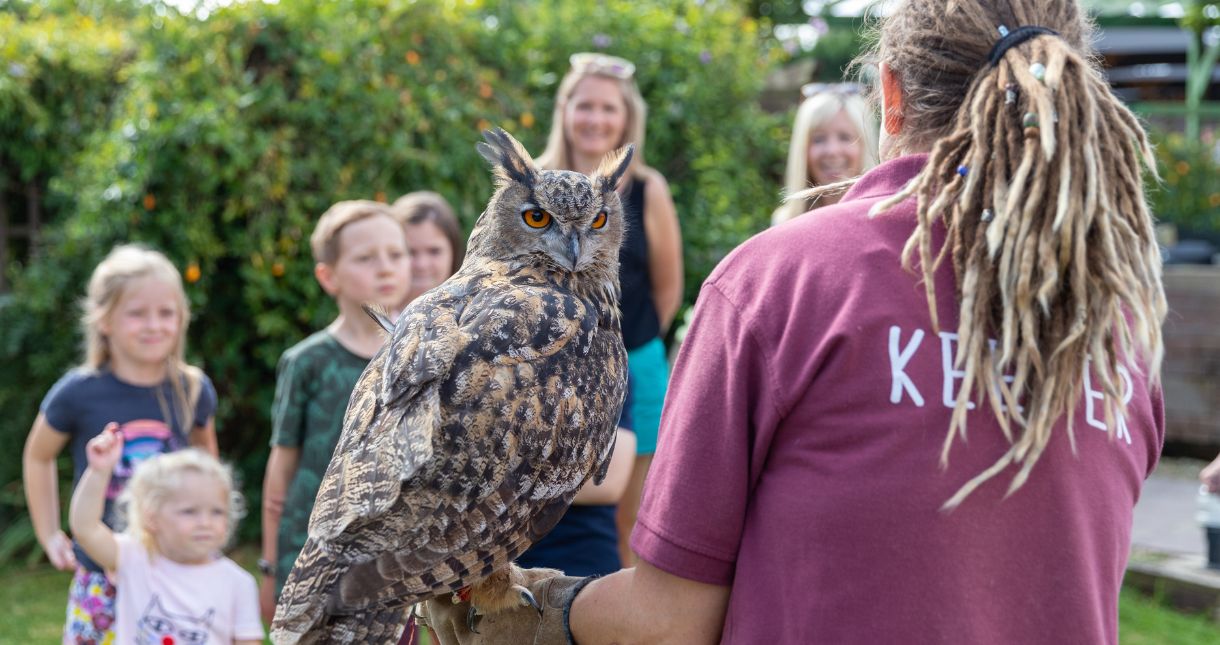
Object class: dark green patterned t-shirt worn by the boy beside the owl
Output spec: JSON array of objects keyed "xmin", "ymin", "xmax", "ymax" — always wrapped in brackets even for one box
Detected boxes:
[{"xmin": 271, "ymin": 330, "xmax": 368, "ymax": 594}]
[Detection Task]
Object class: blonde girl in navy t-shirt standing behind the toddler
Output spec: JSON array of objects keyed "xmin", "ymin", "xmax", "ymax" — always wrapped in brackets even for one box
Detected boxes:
[{"xmin": 22, "ymin": 245, "xmax": 217, "ymax": 643}]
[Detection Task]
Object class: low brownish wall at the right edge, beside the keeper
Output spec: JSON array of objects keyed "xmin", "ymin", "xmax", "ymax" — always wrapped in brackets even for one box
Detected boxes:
[{"xmin": 1161, "ymin": 266, "xmax": 1220, "ymax": 447}]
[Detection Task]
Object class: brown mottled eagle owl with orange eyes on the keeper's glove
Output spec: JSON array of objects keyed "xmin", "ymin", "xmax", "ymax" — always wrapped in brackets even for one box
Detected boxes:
[{"xmin": 272, "ymin": 130, "xmax": 632, "ymax": 643}]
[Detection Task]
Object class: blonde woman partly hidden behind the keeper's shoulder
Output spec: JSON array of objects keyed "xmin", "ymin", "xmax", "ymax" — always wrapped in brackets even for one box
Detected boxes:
[{"xmin": 771, "ymin": 83, "xmax": 877, "ymax": 226}]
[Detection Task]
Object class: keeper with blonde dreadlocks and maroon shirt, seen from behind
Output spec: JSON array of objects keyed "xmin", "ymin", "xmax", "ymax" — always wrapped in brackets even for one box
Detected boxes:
[{"xmin": 429, "ymin": 0, "xmax": 1165, "ymax": 645}]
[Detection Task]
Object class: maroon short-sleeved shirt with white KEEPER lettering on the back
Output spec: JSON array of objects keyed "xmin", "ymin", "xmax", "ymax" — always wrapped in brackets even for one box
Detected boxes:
[{"xmin": 632, "ymin": 156, "xmax": 1164, "ymax": 644}]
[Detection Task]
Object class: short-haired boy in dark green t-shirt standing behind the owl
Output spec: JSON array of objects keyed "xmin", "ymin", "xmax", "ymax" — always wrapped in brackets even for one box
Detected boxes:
[{"xmin": 259, "ymin": 201, "xmax": 411, "ymax": 623}]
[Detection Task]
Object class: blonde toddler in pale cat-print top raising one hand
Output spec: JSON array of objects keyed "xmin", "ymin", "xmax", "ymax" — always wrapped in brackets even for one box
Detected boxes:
[{"xmin": 70, "ymin": 424, "xmax": 264, "ymax": 645}]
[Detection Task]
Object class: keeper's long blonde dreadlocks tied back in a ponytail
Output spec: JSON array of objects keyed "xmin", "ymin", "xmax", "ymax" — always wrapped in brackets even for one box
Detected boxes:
[{"xmin": 858, "ymin": 0, "xmax": 1165, "ymax": 508}]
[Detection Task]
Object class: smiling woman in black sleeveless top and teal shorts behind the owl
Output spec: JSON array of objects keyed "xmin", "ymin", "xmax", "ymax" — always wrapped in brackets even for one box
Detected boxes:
[{"xmin": 538, "ymin": 52, "xmax": 682, "ymax": 563}]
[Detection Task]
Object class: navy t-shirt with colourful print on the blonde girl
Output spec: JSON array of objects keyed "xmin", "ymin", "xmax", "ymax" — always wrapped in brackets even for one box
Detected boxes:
[{"xmin": 40, "ymin": 368, "xmax": 216, "ymax": 572}]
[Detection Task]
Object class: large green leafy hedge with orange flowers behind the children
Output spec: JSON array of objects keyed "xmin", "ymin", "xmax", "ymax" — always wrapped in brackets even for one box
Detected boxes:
[{"xmin": 0, "ymin": 0, "xmax": 787, "ymax": 558}]
